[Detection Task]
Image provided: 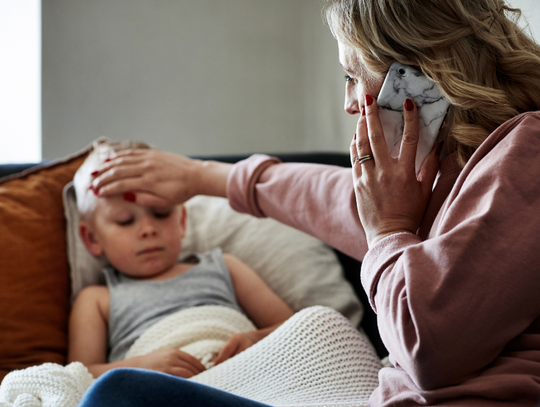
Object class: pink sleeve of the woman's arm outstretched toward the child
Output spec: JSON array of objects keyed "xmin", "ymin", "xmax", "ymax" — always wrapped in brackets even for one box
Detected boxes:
[{"xmin": 227, "ymin": 155, "xmax": 367, "ymax": 260}]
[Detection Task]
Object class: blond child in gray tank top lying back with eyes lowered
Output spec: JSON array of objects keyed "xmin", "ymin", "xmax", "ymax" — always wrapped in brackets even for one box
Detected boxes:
[{"xmin": 68, "ymin": 143, "xmax": 293, "ymax": 378}]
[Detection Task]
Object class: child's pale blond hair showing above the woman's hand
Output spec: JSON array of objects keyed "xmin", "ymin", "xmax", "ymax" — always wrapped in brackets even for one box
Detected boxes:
[{"xmin": 73, "ymin": 139, "xmax": 151, "ymax": 219}]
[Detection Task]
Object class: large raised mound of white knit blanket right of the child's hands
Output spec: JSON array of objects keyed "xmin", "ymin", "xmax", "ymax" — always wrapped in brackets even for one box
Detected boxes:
[{"xmin": 191, "ymin": 306, "xmax": 382, "ymax": 407}]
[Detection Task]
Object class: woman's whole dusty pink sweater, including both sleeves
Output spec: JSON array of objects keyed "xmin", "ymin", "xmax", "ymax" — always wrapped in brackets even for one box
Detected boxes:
[{"xmin": 228, "ymin": 112, "xmax": 540, "ymax": 406}]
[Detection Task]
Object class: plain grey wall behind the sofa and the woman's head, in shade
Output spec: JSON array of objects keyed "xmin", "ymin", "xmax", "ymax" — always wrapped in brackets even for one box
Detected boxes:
[{"xmin": 42, "ymin": 0, "xmax": 540, "ymax": 158}]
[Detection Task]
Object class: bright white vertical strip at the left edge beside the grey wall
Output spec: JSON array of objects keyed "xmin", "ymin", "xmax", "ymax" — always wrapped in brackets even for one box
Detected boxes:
[{"xmin": 0, "ymin": 0, "xmax": 41, "ymax": 164}]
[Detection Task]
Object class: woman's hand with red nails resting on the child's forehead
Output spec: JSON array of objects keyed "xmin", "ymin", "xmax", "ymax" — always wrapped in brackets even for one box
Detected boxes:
[{"xmin": 92, "ymin": 149, "xmax": 232, "ymax": 206}]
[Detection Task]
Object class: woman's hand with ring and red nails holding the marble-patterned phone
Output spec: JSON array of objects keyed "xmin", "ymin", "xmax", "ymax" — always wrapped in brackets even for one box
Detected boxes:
[{"xmin": 351, "ymin": 95, "xmax": 439, "ymax": 247}]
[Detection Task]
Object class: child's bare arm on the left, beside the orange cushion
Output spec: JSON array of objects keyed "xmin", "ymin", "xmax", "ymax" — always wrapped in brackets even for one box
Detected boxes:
[{"xmin": 68, "ymin": 286, "xmax": 206, "ymax": 378}]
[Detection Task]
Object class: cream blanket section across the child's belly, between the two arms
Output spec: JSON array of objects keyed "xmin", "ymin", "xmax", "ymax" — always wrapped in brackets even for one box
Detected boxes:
[{"xmin": 125, "ymin": 305, "xmax": 257, "ymax": 368}]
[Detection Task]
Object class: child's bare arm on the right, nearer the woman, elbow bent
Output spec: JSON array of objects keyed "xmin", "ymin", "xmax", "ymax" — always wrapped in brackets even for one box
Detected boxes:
[{"xmin": 214, "ymin": 254, "xmax": 293, "ymax": 365}]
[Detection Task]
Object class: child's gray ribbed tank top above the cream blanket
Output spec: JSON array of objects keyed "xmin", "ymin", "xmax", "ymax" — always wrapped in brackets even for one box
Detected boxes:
[{"xmin": 103, "ymin": 249, "xmax": 243, "ymax": 362}]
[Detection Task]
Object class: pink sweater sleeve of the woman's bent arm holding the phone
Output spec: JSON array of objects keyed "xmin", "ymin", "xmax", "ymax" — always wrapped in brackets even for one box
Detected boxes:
[{"xmin": 361, "ymin": 114, "xmax": 540, "ymax": 390}]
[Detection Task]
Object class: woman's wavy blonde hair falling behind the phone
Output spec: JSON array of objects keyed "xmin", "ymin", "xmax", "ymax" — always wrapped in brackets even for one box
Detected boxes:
[{"xmin": 323, "ymin": 0, "xmax": 540, "ymax": 165}]
